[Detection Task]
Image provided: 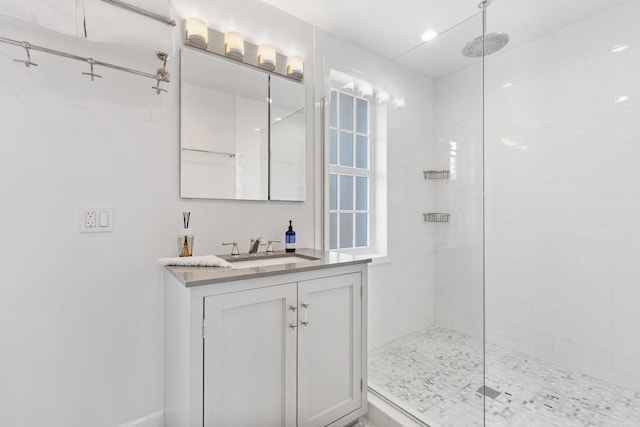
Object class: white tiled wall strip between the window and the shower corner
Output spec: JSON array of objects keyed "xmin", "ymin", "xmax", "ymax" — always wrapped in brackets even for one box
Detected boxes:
[{"xmin": 369, "ymin": 67, "xmax": 435, "ymax": 348}]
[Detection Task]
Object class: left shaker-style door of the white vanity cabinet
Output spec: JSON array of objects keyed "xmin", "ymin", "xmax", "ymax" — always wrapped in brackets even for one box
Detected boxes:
[{"xmin": 204, "ymin": 283, "xmax": 297, "ymax": 427}]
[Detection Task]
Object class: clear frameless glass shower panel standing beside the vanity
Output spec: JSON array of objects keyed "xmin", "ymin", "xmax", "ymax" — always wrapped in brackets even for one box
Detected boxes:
[{"xmin": 369, "ymin": 9, "xmax": 484, "ymax": 426}]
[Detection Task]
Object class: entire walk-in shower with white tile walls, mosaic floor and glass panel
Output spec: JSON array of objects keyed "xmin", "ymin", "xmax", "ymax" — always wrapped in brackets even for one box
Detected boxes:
[{"xmin": 315, "ymin": 0, "xmax": 640, "ymax": 427}]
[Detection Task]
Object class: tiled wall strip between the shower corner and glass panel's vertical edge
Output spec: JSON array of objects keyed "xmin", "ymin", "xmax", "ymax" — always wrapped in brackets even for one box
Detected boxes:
[{"xmin": 429, "ymin": 56, "xmax": 483, "ymax": 339}]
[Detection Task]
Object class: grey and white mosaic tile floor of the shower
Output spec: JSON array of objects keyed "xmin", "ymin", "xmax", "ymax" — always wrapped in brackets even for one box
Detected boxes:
[{"xmin": 369, "ymin": 327, "xmax": 640, "ymax": 427}]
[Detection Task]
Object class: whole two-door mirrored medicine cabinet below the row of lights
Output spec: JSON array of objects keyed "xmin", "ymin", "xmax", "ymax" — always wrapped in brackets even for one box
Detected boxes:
[{"xmin": 180, "ymin": 48, "xmax": 306, "ymax": 201}]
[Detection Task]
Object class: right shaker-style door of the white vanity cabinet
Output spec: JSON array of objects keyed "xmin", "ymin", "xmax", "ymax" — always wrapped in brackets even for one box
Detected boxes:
[{"xmin": 298, "ymin": 273, "xmax": 362, "ymax": 427}]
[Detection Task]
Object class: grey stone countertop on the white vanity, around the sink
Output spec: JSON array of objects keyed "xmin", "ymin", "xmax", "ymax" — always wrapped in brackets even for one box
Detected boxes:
[{"xmin": 165, "ymin": 249, "xmax": 371, "ymax": 287}]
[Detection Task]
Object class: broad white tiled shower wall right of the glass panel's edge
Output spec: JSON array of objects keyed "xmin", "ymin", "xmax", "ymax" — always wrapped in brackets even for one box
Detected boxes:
[{"xmin": 436, "ymin": 1, "xmax": 640, "ymax": 390}]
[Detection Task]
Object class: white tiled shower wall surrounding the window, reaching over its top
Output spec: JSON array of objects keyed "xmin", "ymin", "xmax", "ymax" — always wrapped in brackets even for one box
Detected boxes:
[{"xmin": 315, "ymin": 29, "xmax": 434, "ymax": 348}]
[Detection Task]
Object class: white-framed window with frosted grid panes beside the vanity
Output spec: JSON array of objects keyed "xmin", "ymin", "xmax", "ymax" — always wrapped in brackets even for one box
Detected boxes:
[{"xmin": 328, "ymin": 89, "xmax": 373, "ymax": 250}]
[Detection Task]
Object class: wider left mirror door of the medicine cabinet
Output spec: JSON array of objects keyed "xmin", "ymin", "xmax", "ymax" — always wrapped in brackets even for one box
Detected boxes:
[{"xmin": 180, "ymin": 49, "xmax": 269, "ymax": 200}]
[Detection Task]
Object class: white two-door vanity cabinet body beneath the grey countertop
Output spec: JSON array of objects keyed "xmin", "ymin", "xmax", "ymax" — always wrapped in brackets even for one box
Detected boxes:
[{"xmin": 164, "ymin": 263, "xmax": 367, "ymax": 427}]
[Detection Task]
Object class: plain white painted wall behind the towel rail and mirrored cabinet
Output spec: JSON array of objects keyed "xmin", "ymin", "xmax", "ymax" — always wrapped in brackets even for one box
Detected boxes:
[{"xmin": 0, "ymin": 2, "xmax": 315, "ymax": 427}]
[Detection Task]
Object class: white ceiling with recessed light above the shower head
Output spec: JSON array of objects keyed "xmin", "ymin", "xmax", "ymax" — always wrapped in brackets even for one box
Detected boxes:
[{"xmin": 263, "ymin": 0, "xmax": 633, "ymax": 79}]
